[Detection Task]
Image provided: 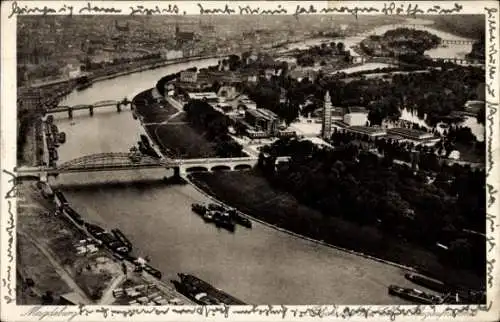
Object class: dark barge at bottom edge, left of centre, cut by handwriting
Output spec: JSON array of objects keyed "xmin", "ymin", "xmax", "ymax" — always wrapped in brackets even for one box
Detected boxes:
[{"xmin": 172, "ymin": 273, "xmax": 246, "ymax": 305}]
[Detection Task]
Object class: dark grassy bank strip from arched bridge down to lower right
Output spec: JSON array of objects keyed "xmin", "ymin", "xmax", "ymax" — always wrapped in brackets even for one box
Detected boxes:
[{"xmin": 191, "ymin": 170, "xmax": 480, "ymax": 286}]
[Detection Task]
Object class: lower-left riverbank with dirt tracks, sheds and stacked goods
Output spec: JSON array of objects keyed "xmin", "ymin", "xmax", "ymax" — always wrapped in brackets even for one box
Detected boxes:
[{"xmin": 17, "ymin": 182, "xmax": 192, "ymax": 305}]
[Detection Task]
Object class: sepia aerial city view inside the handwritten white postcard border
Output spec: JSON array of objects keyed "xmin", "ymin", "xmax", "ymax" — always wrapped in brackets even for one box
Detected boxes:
[{"xmin": 13, "ymin": 9, "xmax": 487, "ymax": 306}]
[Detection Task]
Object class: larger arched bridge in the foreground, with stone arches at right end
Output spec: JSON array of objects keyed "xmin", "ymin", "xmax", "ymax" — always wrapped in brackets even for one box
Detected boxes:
[{"xmin": 16, "ymin": 152, "xmax": 258, "ymax": 177}]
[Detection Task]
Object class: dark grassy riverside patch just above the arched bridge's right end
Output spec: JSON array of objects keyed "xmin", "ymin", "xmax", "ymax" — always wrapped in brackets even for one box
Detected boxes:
[{"xmin": 153, "ymin": 124, "xmax": 217, "ymax": 159}]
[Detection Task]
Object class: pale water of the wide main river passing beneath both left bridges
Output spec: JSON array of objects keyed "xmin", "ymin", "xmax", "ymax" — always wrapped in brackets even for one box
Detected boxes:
[{"xmin": 52, "ymin": 22, "xmax": 480, "ymax": 304}]
